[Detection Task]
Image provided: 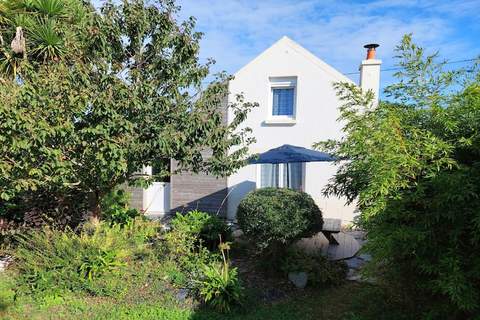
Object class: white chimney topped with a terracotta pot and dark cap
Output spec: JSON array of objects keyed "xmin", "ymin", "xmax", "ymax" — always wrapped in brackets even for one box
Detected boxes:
[{"xmin": 360, "ymin": 43, "xmax": 382, "ymax": 104}]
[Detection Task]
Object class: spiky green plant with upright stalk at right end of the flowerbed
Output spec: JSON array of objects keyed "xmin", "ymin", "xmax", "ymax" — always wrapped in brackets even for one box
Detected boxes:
[{"xmin": 197, "ymin": 243, "xmax": 243, "ymax": 312}]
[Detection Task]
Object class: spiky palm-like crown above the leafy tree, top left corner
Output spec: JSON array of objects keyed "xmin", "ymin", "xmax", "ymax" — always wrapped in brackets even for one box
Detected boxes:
[{"xmin": 0, "ymin": 0, "xmax": 88, "ymax": 76}]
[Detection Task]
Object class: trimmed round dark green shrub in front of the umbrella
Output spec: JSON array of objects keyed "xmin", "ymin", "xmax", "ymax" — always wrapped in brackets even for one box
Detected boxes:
[{"xmin": 237, "ymin": 188, "xmax": 323, "ymax": 251}]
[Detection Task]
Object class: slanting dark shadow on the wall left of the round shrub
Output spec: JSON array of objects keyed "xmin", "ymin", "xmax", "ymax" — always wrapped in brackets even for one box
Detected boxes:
[{"xmin": 170, "ymin": 181, "xmax": 255, "ymax": 218}]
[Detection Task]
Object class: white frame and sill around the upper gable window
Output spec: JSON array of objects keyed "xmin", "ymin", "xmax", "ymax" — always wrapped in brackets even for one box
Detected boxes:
[{"xmin": 265, "ymin": 76, "xmax": 297, "ymax": 124}]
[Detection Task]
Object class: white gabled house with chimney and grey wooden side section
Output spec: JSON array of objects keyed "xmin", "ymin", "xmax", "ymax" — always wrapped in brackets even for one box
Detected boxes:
[{"xmin": 129, "ymin": 37, "xmax": 381, "ymax": 223}]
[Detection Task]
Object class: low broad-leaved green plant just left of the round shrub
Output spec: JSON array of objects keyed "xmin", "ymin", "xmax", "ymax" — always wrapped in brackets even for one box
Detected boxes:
[{"xmin": 172, "ymin": 210, "xmax": 232, "ymax": 251}]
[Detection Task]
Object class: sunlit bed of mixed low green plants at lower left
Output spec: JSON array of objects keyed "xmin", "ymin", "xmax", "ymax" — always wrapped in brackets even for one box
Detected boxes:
[{"xmin": 0, "ymin": 211, "xmax": 246, "ymax": 318}]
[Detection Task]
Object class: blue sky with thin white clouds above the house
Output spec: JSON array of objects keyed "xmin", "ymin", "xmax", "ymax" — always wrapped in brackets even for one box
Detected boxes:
[{"xmin": 178, "ymin": 0, "xmax": 480, "ymax": 93}]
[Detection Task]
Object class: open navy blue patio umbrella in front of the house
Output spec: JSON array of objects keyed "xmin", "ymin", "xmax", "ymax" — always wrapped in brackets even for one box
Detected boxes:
[{"xmin": 248, "ymin": 144, "xmax": 335, "ymax": 164}]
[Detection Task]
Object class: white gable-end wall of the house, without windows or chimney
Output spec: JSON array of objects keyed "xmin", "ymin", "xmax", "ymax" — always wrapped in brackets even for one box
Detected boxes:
[{"xmin": 228, "ymin": 38, "xmax": 354, "ymax": 223}]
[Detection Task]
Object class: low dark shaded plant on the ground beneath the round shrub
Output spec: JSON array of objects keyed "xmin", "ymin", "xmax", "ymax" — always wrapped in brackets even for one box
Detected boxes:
[{"xmin": 280, "ymin": 249, "xmax": 348, "ymax": 287}]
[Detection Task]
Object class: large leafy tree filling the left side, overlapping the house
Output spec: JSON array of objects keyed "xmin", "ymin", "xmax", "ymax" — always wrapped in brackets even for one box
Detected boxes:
[{"xmin": 0, "ymin": 0, "xmax": 254, "ymax": 222}]
